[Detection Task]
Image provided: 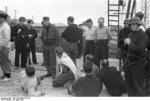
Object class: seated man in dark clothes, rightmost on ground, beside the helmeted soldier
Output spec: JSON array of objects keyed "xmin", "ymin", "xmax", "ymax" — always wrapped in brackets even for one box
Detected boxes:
[{"xmin": 99, "ymin": 61, "xmax": 125, "ymax": 96}]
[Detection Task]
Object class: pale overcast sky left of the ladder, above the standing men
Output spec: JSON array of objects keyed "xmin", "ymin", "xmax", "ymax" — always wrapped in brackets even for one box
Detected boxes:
[{"xmin": 0, "ymin": 0, "xmax": 107, "ymax": 25}]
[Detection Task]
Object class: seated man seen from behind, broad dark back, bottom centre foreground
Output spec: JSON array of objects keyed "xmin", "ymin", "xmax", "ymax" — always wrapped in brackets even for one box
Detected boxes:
[{"xmin": 68, "ymin": 62, "xmax": 102, "ymax": 96}]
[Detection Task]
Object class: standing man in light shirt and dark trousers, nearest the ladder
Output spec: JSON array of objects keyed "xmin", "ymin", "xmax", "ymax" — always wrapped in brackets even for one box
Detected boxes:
[{"xmin": 95, "ymin": 17, "xmax": 112, "ymax": 67}]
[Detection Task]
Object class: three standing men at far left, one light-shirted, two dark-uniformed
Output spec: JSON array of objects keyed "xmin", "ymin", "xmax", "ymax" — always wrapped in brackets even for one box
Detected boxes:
[{"xmin": 0, "ymin": 11, "xmax": 37, "ymax": 81}]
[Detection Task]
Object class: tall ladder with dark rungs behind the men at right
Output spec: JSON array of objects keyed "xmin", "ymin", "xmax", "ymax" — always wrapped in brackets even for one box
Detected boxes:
[{"xmin": 108, "ymin": 0, "xmax": 123, "ymax": 69}]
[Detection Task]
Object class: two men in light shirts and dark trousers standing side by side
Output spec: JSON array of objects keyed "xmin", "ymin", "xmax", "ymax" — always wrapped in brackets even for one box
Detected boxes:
[{"xmin": 81, "ymin": 17, "xmax": 112, "ymax": 67}]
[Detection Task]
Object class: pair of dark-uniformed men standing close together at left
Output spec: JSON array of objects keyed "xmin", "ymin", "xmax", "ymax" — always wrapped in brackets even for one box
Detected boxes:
[{"xmin": 11, "ymin": 17, "xmax": 37, "ymax": 68}]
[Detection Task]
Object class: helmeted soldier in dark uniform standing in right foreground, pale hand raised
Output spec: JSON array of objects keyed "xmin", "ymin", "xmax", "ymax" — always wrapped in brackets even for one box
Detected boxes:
[{"xmin": 124, "ymin": 17, "xmax": 148, "ymax": 96}]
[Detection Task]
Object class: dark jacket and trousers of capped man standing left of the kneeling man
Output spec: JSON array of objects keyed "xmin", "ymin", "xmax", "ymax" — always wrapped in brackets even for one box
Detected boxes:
[{"xmin": 41, "ymin": 24, "xmax": 60, "ymax": 77}]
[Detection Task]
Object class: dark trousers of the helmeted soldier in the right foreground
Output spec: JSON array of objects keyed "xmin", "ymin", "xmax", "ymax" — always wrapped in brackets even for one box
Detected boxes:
[{"xmin": 125, "ymin": 63, "xmax": 145, "ymax": 96}]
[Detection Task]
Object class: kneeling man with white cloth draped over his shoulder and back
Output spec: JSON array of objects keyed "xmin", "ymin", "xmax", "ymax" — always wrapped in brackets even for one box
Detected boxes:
[{"xmin": 53, "ymin": 47, "xmax": 77, "ymax": 87}]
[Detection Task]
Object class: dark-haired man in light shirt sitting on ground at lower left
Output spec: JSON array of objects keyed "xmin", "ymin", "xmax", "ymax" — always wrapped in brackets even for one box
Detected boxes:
[{"xmin": 21, "ymin": 67, "xmax": 44, "ymax": 96}]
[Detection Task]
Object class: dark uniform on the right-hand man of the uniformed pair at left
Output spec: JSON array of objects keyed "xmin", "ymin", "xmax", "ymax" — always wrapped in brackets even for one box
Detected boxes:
[{"xmin": 29, "ymin": 28, "xmax": 37, "ymax": 63}]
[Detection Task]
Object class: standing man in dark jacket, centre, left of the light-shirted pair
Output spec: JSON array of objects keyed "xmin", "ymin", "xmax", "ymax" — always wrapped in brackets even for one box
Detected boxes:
[{"xmin": 61, "ymin": 16, "xmax": 82, "ymax": 64}]
